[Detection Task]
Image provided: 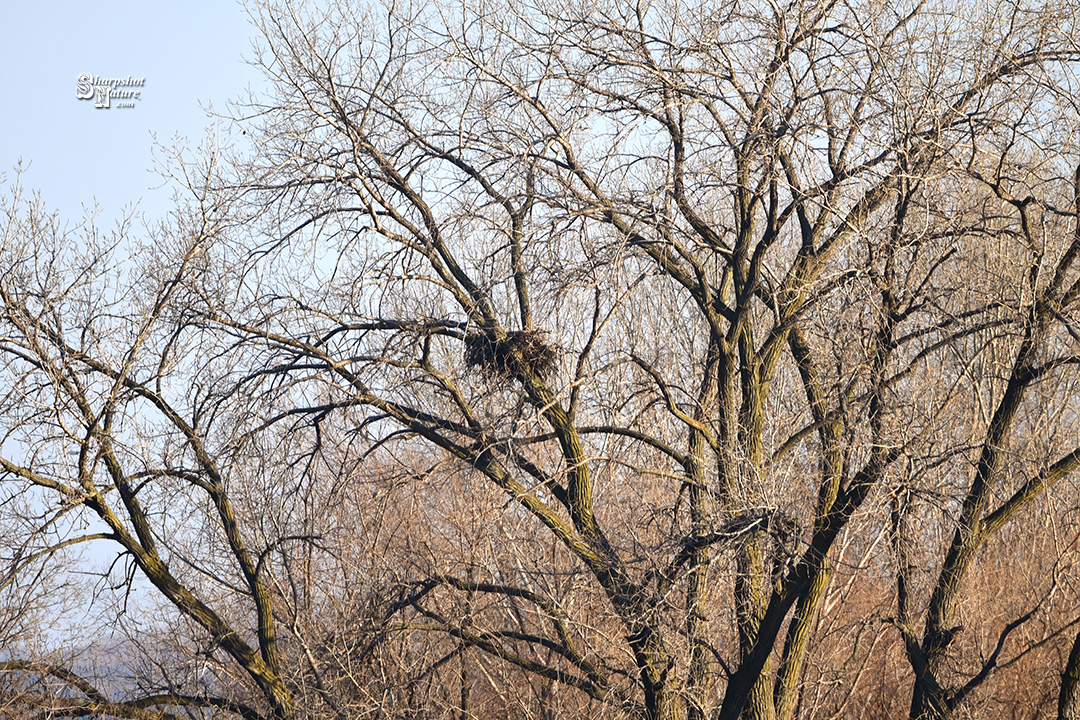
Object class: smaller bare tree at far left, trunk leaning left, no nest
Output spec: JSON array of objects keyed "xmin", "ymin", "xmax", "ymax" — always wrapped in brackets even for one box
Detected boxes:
[{"xmin": 0, "ymin": 172, "xmax": 308, "ymax": 717}]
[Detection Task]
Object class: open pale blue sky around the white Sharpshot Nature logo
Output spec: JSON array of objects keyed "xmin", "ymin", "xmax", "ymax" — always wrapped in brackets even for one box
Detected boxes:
[{"xmin": 0, "ymin": 0, "xmax": 266, "ymax": 228}]
